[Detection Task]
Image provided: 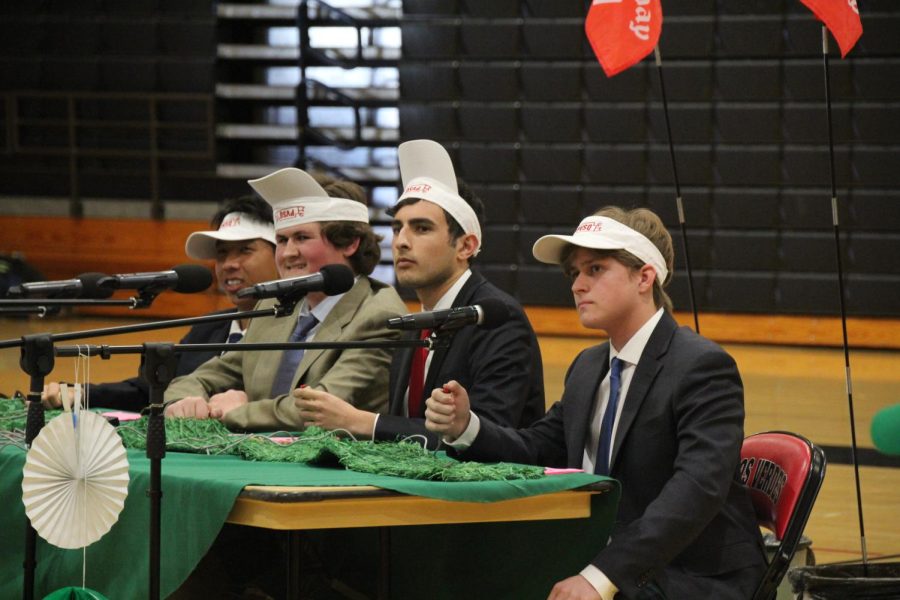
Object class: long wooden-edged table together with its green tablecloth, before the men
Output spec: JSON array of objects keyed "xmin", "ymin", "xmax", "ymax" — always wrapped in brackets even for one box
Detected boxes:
[{"xmin": 0, "ymin": 447, "xmax": 618, "ymax": 598}]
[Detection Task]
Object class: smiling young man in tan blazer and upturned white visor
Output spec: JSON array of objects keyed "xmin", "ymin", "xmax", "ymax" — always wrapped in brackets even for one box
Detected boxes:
[{"xmin": 165, "ymin": 168, "xmax": 406, "ymax": 431}]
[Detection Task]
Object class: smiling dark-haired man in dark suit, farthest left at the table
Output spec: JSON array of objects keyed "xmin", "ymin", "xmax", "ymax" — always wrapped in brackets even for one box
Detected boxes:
[{"xmin": 42, "ymin": 196, "xmax": 278, "ymax": 411}]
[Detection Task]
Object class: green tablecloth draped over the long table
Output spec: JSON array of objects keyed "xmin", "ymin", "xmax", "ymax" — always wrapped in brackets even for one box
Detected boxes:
[{"xmin": 0, "ymin": 447, "xmax": 618, "ymax": 598}]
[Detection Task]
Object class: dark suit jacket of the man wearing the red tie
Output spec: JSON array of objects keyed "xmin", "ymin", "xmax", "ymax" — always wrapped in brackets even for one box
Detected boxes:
[{"xmin": 375, "ymin": 272, "xmax": 545, "ymax": 447}]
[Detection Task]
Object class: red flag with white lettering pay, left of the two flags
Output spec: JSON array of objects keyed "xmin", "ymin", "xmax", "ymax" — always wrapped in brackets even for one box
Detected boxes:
[{"xmin": 584, "ymin": 0, "xmax": 662, "ymax": 77}]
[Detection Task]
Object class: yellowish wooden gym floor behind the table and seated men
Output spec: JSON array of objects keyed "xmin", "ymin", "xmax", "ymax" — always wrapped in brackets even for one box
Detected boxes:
[{"xmin": 0, "ymin": 317, "xmax": 900, "ymax": 564}]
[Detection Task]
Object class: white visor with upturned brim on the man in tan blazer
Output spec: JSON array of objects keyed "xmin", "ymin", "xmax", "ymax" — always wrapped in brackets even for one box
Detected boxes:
[{"xmin": 247, "ymin": 167, "xmax": 369, "ymax": 231}]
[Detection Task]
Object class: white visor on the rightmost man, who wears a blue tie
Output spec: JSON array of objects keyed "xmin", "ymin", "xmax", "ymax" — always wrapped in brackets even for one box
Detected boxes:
[{"xmin": 531, "ymin": 216, "xmax": 669, "ymax": 284}]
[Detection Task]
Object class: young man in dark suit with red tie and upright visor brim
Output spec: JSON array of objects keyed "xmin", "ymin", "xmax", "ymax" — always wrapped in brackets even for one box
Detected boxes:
[{"xmin": 294, "ymin": 140, "xmax": 544, "ymax": 448}]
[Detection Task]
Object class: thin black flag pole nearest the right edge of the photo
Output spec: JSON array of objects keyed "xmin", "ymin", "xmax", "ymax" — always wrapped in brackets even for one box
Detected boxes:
[{"xmin": 822, "ymin": 25, "xmax": 869, "ymax": 576}]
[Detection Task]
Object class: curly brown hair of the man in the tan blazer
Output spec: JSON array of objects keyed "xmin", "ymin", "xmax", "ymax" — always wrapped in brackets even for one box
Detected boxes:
[{"xmin": 312, "ymin": 173, "xmax": 384, "ymax": 275}]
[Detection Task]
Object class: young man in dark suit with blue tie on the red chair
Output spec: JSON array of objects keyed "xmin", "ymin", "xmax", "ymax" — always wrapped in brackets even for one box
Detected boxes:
[{"xmin": 425, "ymin": 207, "xmax": 765, "ymax": 600}]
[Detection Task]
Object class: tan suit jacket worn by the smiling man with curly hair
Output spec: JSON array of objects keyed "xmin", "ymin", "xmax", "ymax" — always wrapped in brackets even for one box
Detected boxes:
[{"xmin": 165, "ymin": 277, "xmax": 406, "ymax": 431}]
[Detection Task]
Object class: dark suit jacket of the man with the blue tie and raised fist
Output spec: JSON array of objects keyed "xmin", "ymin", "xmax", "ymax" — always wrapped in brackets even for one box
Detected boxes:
[{"xmin": 463, "ymin": 314, "xmax": 765, "ymax": 599}]
